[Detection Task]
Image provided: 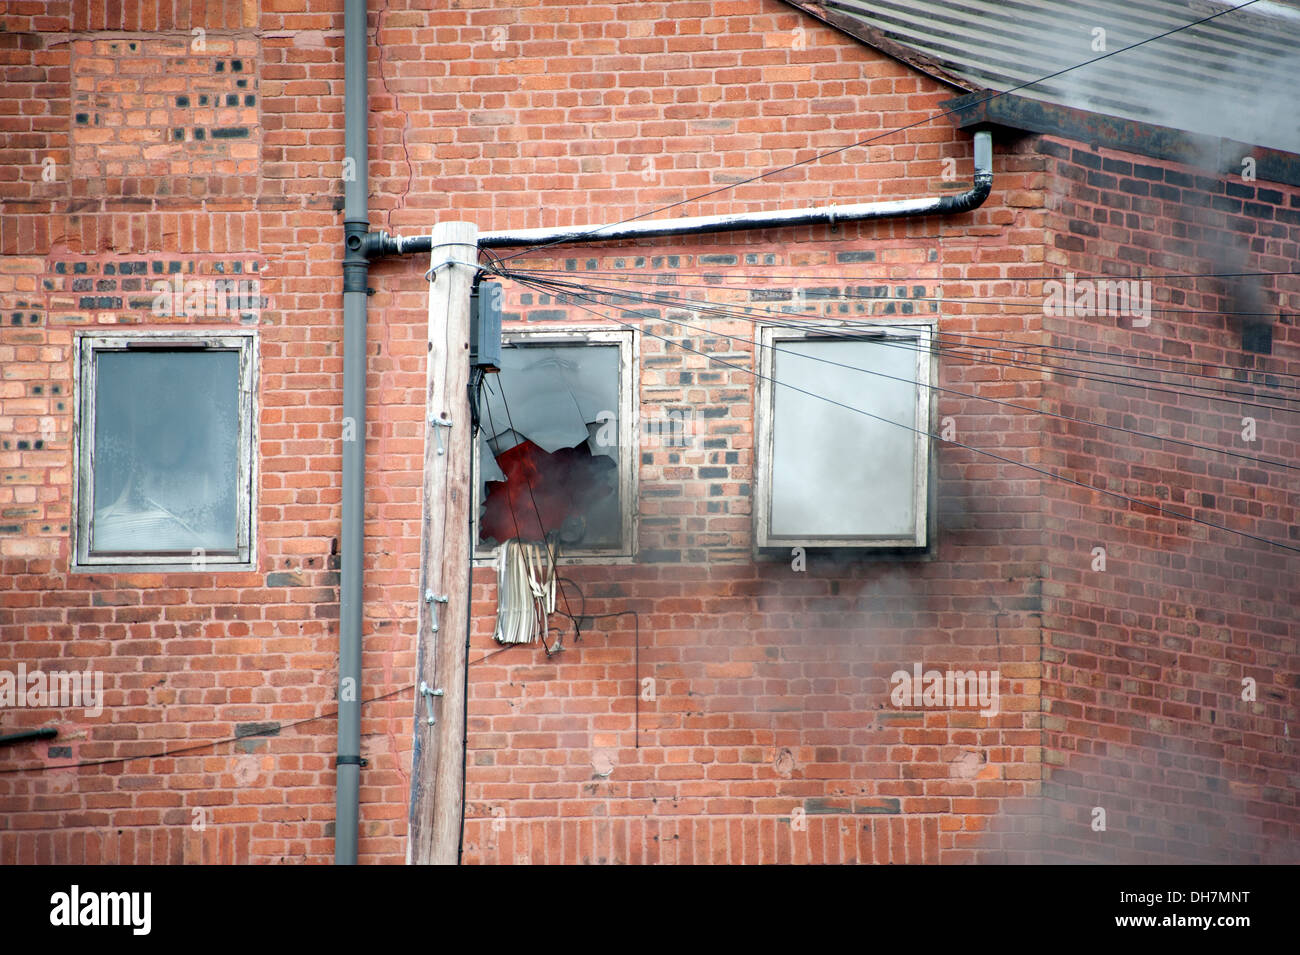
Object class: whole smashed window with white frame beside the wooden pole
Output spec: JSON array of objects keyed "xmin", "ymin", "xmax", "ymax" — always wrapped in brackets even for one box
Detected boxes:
[{"xmin": 476, "ymin": 329, "xmax": 637, "ymax": 559}]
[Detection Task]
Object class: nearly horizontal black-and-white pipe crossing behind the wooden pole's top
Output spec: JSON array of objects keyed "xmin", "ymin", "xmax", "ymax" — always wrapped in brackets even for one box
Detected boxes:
[{"xmin": 367, "ymin": 130, "xmax": 993, "ymax": 255}]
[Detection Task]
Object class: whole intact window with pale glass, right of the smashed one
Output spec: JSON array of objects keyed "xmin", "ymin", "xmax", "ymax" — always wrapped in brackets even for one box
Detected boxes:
[{"xmin": 754, "ymin": 322, "xmax": 932, "ymax": 548}]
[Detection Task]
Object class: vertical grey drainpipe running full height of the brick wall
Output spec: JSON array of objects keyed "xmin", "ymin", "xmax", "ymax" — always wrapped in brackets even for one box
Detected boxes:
[{"xmin": 334, "ymin": 0, "xmax": 371, "ymax": 865}]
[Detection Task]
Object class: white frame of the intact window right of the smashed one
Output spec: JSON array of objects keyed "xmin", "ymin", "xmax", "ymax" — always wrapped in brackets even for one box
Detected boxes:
[{"xmin": 754, "ymin": 318, "xmax": 937, "ymax": 552}]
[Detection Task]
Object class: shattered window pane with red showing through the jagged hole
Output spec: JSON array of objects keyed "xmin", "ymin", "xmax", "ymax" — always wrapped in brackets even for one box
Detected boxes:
[{"xmin": 478, "ymin": 344, "xmax": 623, "ymax": 550}]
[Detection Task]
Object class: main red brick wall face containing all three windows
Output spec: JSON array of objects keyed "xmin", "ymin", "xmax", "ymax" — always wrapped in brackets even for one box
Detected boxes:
[{"xmin": 0, "ymin": 0, "xmax": 1294, "ymax": 863}]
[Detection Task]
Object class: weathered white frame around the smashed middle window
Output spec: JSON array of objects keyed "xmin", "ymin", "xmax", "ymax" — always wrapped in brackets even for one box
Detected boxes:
[{"xmin": 472, "ymin": 325, "xmax": 641, "ymax": 567}]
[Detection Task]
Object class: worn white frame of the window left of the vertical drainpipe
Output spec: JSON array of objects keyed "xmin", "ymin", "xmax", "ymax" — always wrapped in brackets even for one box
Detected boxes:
[{"xmin": 70, "ymin": 327, "xmax": 259, "ymax": 573}]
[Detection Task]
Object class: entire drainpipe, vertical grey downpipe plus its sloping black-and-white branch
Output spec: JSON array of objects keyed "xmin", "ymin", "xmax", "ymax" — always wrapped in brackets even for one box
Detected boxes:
[{"xmin": 334, "ymin": 0, "xmax": 993, "ymax": 865}]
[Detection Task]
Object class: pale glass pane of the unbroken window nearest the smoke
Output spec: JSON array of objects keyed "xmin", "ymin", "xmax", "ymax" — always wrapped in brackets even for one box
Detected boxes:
[{"xmin": 771, "ymin": 338, "xmax": 918, "ymax": 537}]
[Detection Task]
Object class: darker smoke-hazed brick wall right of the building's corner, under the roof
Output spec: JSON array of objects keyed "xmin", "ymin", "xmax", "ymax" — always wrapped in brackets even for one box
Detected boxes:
[{"xmin": 1030, "ymin": 140, "xmax": 1300, "ymax": 863}]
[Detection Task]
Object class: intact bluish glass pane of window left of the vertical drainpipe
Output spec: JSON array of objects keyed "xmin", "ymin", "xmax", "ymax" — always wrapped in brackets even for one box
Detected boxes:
[{"xmin": 91, "ymin": 351, "xmax": 239, "ymax": 554}]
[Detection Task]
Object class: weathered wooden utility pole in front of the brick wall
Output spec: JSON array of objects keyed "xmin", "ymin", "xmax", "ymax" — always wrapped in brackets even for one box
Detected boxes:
[{"xmin": 407, "ymin": 222, "xmax": 478, "ymax": 865}]
